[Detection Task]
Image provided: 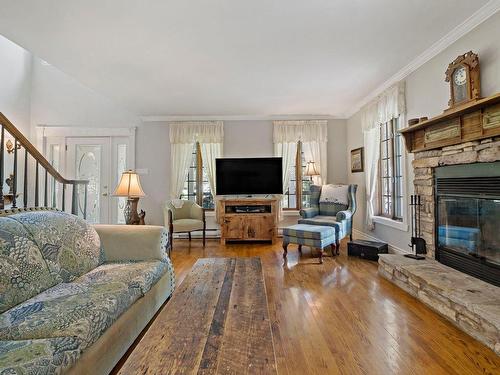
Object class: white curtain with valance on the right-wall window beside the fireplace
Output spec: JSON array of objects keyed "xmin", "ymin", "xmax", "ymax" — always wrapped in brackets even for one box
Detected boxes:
[{"xmin": 361, "ymin": 81, "xmax": 406, "ymax": 229}]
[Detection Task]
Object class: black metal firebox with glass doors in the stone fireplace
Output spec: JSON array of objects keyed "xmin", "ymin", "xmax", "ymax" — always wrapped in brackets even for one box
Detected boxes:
[{"xmin": 434, "ymin": 162, "xmax": 500, "ymax": 286}]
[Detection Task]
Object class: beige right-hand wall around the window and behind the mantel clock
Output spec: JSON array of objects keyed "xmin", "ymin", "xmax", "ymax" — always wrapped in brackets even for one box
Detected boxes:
[{"xmin": 347, "ymin": 12, "xmax": 500, "ymax": 251}]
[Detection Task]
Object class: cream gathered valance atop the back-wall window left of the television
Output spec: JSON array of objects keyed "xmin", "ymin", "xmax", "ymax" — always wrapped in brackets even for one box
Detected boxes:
[{"xmin": 170, "ymin": 121, "xmax": 224, "ymax": 144}]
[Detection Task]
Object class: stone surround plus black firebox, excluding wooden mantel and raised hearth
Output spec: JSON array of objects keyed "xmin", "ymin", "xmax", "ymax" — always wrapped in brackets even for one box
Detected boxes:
[{"xmin": 413, "ymin": 137, "xmax": 500, "ymax": 285}]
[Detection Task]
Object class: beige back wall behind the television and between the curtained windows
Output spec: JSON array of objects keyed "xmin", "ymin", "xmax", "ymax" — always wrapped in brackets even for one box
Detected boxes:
[{"xmin": 141, "ymin": 120, "xmax": 347, "ymax": 227}]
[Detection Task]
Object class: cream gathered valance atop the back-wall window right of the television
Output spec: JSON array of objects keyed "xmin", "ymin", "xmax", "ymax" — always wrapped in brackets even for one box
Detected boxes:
[{"xmin": 273, "ymin": 120, "xmax": 328, "ymax": 143}]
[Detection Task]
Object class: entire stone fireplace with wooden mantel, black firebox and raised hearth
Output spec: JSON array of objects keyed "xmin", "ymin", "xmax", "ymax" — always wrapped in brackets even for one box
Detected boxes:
[{"xmin": 378, "ymin": 93, "xmax": 500, "ymax": 355}]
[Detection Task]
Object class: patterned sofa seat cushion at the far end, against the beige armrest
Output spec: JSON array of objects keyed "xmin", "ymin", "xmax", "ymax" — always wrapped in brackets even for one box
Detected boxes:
[{"xmin": 75, "ymin": 260, "xmax": 173, "ymax": 295}]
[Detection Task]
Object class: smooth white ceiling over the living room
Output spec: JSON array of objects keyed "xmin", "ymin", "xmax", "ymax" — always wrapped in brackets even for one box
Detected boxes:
[{"xmin": 0, "ymin": 0, "xmax": 487, "ymax": 117}]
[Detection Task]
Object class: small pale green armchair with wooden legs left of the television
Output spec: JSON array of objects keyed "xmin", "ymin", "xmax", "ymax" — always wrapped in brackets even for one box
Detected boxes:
[{"xmin": 163, "ymin": 200, "xmax": 206, "ymax": 248}]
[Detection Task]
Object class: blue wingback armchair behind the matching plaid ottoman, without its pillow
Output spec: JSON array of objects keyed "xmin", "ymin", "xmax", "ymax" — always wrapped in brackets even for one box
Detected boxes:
[{"xmin": 299, "ymin": 185, "xmax": 358, "ymax": 246}]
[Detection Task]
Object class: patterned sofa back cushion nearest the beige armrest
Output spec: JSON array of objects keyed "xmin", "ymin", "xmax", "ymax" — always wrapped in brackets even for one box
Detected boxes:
[{"xmin": 10, "ymin": 211, "xmax": 102, "ymax": 282}]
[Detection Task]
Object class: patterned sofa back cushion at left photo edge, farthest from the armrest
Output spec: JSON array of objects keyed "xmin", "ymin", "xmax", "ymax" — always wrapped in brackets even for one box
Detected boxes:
[{"xmin": 0, "ymin": 217, "xmax": 57, "ymax": 313}]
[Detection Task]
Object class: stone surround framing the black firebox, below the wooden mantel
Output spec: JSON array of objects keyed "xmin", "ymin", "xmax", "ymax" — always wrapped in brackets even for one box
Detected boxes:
[{"xmin": 413, "ymin": 137, "xmax": 500, "ymax": 259}]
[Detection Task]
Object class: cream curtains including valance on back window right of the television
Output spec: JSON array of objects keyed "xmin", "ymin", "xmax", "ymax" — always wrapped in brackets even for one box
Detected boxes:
[{"xmin": 273, "ymin": 120, "xmax": 328, "ymax": 217}]
